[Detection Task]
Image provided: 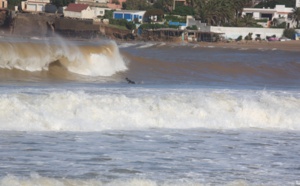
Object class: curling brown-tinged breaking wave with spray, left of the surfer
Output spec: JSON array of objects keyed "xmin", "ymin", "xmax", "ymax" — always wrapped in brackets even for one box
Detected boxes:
[{"xmin": 0, "ymin": 37, "xmax": 127, "ymax": 76}]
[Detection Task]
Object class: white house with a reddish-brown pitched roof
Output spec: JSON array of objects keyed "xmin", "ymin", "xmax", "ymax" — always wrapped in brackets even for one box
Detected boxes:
[{"xmin": 64, "ymin": 3, "xmax": 95, "ymax": 19}]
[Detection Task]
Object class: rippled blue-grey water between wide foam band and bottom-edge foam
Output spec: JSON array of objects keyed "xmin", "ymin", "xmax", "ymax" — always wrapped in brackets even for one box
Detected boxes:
[{"xmin": 0, "ymin": 129, "xmax": 300, "ymax": 185}]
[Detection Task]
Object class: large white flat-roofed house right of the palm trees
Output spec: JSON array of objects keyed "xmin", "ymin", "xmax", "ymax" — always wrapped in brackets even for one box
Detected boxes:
[{"xmin": 242, "ymin": 5, "xmax": 294, "ymax": 27}]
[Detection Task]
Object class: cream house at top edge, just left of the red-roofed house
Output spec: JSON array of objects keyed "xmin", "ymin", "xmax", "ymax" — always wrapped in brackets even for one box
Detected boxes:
[{"xmin": 21, "ymin": 0, "xmax": 50, "ymax": 12}]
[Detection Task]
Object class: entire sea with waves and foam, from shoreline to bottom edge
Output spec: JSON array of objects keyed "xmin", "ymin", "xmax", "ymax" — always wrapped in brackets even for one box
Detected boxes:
[{"xmin": 0, "ymin": 37, "xmax": 300, "ymax": 186}]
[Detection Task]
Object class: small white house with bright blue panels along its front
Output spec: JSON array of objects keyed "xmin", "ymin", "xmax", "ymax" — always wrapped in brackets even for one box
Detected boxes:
[{"xmin": 113, "ymin": 10, "xmax": 146, "ymax": 22}]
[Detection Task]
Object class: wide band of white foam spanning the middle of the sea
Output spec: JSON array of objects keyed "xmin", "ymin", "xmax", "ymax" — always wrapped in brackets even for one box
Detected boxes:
[{"xmin": 0, "ymin": 89, "xmax": 300, "ymax": 131}]
